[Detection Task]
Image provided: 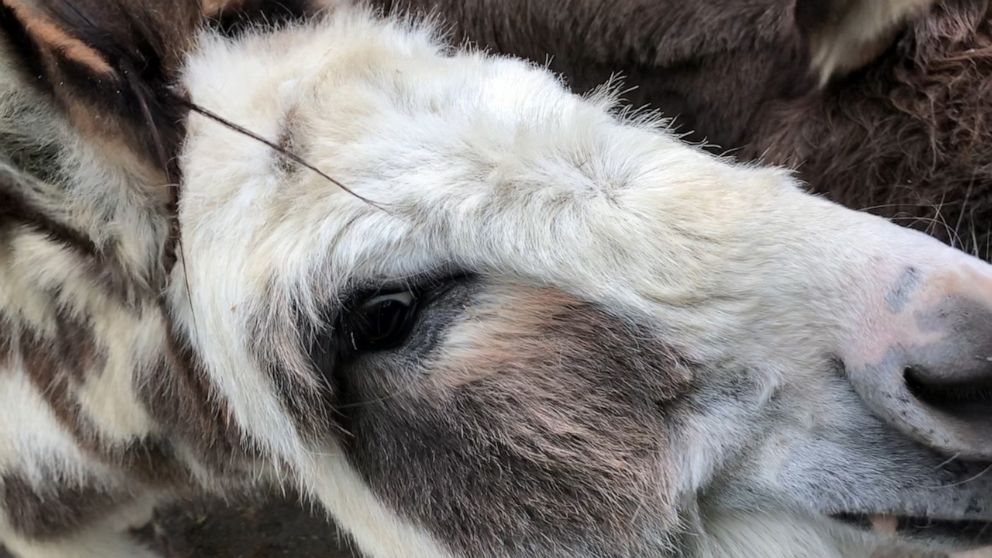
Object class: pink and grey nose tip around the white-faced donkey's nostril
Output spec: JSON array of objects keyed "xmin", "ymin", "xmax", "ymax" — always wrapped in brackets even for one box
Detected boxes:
[{"xmin": 845, "ymin": 264, "xmax": 992, "ymax": 460}]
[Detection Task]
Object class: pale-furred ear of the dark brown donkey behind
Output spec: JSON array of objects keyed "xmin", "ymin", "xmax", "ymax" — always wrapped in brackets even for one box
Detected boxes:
[{"xmin": 796, "ymin": 0, "xmax": 936, "ymax": 85}]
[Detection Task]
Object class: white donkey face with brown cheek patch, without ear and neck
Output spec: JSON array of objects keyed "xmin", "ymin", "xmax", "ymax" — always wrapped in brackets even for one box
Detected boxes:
[{"xmin": 1, "ymin": 1, "xmax": 992, "ymax": 557}]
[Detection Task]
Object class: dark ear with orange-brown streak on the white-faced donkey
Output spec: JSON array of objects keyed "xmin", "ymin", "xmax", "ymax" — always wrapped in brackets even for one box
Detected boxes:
[{"xmin": 0, "ymin": 0, "xmax": 202, "ymax": 174}]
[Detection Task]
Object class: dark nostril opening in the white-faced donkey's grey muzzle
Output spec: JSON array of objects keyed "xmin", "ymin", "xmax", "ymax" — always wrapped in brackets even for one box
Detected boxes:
[{"xmin": 903, "ymin": 366, "xmax": 992, "ymax": 426}]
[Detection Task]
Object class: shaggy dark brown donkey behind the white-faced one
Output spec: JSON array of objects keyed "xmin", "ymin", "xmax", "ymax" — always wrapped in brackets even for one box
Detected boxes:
[{"xmin": 374, "ymin": 0, "xmax": 992, "ymax": 260}]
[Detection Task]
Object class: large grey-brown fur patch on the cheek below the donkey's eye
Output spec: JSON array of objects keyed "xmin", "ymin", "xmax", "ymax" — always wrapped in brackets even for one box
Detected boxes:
[{"xmin": 335, "ymin": 287, "xmax": 691, "ymax": 558}]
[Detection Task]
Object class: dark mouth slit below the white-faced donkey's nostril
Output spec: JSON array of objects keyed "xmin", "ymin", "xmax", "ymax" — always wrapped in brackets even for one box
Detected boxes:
[{"xmin": 831, "ymin": 512, "xmax": 992, "ymax": 546}]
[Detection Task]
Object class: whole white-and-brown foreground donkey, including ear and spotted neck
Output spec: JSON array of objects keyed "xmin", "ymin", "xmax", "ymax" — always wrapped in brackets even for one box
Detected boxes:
[{"xmin": 0, "ymin": 0, "xmax": 992, "ymax": 558}]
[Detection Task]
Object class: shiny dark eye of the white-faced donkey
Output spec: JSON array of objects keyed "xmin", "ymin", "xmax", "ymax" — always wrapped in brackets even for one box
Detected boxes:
[{"xmin": 344, "ymin": 291, "xmax": 417, "ymax": 353}]
